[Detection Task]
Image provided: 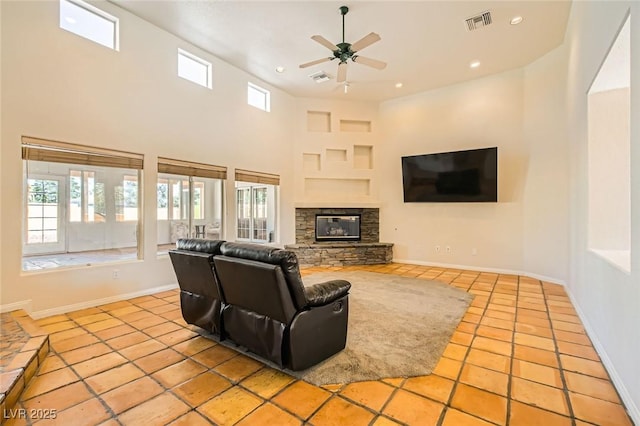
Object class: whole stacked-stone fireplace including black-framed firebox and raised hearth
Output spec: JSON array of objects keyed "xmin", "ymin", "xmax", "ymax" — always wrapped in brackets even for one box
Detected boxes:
[{"xmin": 285, "ymin": 208, "xmax": 393, "ymax": 266}]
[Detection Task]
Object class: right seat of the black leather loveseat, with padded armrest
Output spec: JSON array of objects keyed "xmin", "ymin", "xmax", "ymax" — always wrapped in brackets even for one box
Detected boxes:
[{"xmin": 213, "ymin": 242, "xmax": 351, "ymax": 371}]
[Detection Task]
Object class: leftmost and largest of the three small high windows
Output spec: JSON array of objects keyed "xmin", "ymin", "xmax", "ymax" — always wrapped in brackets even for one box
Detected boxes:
[{"xmin": 60, "ymin": 0, "xmax": 118, "ymax": 50}]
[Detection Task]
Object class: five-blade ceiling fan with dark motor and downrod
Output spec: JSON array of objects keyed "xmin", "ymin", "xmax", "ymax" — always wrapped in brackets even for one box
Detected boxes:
[{"xmin": 300, "ymin": 6, "xmax": 387, "ymax": 83}]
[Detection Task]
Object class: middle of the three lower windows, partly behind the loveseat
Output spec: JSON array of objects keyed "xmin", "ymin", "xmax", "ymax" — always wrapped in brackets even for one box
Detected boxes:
[{"xmin": 156, "ymin": 157, "xmax": 227, "ymax": 254}]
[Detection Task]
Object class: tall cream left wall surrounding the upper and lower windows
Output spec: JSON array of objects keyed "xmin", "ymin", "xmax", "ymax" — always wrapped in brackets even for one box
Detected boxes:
[{"xmin": 0, "ymin": 1, "xmax": 294, "ymax": 312}]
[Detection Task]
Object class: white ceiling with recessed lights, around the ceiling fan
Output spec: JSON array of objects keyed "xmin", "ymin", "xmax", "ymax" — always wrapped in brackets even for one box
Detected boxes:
[{"xmin": 111, "ymin": 0, "xmax": 571, "ymax": 101}]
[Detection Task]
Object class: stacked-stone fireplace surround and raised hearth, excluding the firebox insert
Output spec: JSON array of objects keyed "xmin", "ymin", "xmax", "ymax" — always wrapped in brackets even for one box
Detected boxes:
[{"xmin": 285, "ymin": 208, "xmax": 393, "ymax": 266}]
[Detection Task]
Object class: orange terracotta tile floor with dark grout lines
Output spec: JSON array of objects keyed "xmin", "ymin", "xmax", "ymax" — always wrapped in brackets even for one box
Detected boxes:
[{"xmin": 3, "ymin": 264, "xmax": 632, "ymax": 426}]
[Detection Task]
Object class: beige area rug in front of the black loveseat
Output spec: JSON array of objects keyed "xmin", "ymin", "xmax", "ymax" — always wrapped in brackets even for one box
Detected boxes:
[{"xmin": 287, "ymin": 271, "xmax": 473, "ymax": 385}]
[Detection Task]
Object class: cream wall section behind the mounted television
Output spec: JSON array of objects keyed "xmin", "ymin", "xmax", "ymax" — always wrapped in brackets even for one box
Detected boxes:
[{"xmin": 379, "ymin": 70, "xmax": 530, "ymax": 271}]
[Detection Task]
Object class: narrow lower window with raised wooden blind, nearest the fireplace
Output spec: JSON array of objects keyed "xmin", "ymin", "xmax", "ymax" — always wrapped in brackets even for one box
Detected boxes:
[{"xmin": 236, "ymin": 169, "xmax": 280, "ymax": 243}]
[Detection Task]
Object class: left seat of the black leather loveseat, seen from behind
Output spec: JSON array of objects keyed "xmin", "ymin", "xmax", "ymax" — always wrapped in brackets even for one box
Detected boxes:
[{"xmin": 169, "ymin": 239, "xmax": 224, "ymax": 336}]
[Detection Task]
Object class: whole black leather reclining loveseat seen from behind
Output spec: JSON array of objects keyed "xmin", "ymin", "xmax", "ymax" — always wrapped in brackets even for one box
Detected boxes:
[{"xmin": 169, "ymin": 239, "xmax": 351, "ymax": 371}]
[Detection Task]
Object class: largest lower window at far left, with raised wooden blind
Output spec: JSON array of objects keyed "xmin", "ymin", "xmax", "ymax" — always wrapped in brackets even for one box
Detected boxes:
[{"xmin": 22, "ymin": 137, "xmax": 143, "ymax": 270}]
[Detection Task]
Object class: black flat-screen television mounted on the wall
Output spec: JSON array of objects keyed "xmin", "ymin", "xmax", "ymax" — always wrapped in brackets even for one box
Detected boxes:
[{"xmin": 402, "ymin": 147, "xmax": 498, "ymax": 203}]
